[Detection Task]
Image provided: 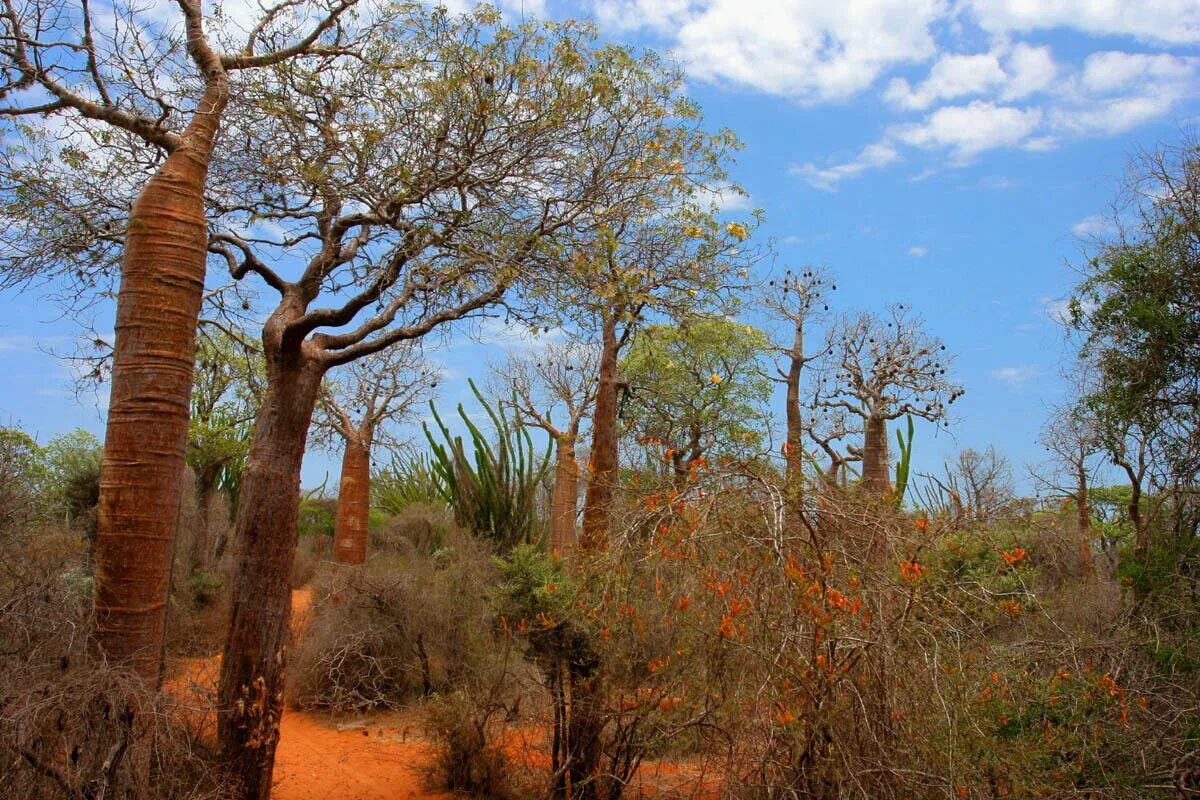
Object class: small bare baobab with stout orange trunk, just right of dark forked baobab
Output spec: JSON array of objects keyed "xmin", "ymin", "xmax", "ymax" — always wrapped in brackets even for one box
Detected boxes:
[{"xmin": 317, "ymin": 345, "xmax": 438, "ymax": 565}]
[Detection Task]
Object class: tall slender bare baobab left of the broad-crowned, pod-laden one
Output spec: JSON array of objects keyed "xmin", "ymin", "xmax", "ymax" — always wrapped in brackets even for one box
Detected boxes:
[{"xmin": 758, "ymin": 266, "xmax": 838, "ymax": 518}]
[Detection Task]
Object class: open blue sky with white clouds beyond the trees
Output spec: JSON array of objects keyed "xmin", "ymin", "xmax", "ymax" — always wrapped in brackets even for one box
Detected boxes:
[{"xmin": 0, "ymin": 0, "xmax": 1200, "ymax": 494}]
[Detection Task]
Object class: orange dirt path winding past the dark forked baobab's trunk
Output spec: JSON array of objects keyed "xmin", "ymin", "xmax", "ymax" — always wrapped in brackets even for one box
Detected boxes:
[{"xmin": 168, "ymin": 588, "xmax": 454, "ymax": 800}]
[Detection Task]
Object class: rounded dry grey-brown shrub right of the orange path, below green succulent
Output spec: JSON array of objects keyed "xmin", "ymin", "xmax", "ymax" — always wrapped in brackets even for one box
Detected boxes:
[{"xmin": 289, "ymin": 531, "xmax": 493, "ymax": 712}]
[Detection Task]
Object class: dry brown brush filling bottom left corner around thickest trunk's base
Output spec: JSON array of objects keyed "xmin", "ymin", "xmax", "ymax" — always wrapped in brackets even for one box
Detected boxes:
[{"xmin": 0, "ymin": 530, "xmax": 218, "ymax": 800}]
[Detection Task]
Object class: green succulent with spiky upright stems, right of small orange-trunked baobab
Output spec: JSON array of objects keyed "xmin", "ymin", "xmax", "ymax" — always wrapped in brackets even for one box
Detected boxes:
[{"xmin": 422, "ymin": 381, "xmax": 552, "ymax": 548}]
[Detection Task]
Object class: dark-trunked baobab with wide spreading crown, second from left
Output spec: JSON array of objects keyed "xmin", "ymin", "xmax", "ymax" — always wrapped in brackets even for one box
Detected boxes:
[{"xmin": 201, "ymin": 12, "xmax": 710, "ymax": 798}]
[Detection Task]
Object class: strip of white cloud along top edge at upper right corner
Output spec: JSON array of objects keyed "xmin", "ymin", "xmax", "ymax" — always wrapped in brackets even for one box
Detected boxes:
[{"xmin": 966, "ymin": 0, "xmax": 1200, "ymax": 44}]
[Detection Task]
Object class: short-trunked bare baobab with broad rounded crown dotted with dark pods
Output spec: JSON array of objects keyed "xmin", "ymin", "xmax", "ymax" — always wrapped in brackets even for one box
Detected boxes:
[{"xmin": 817, "ymin": 305, "xmax": 964, "ymax": 495}]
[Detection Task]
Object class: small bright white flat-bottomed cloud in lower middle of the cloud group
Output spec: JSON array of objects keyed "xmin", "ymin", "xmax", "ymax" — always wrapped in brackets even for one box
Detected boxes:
[{"xmin": 892, "ymin": 100, "xmax": 1042, "ymax": 164}]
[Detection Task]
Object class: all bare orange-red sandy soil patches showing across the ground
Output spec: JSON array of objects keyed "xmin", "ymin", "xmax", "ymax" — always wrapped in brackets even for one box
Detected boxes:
[{"xmin": 167, "ymin": 588, "xmax": 720, "ymax": 800}]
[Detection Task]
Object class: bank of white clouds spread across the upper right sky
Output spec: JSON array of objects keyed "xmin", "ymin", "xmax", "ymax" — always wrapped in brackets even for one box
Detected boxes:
[{"xmin": 573, "ymin": 0, "xmax": 1200, "ymax": 190}]
